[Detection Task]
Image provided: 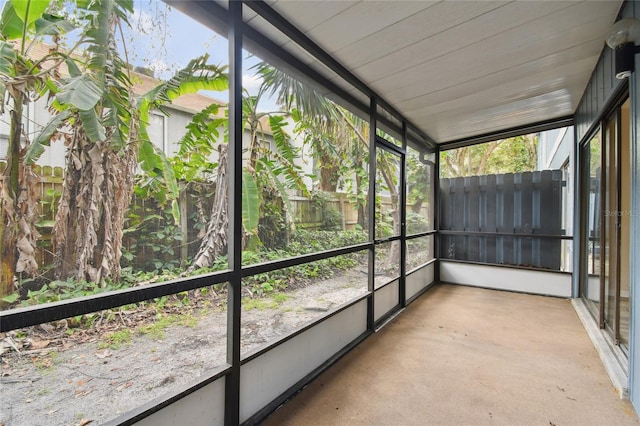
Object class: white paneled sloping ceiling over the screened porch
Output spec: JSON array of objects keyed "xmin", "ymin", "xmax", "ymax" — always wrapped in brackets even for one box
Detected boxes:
[{"xmin": 254, "ymin": 0, "xmax": 622, "ymax": 143}]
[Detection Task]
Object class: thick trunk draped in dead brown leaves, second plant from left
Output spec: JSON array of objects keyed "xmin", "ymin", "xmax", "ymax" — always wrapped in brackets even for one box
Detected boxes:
[{"xmin": 53, "ymin": 125, "xmax": 137, "ymax": 282}]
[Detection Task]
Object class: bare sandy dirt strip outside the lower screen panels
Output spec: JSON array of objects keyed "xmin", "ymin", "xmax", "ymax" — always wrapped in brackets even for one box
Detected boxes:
[{"xmin": 0, "ymin": 267, "xmax": 376, "ymax": 426}]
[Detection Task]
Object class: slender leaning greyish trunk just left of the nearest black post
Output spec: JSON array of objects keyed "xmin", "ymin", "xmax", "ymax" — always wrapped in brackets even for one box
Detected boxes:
[{"xmin": 186, "ymin": 144, "xmax": 229, "ymax": 273}]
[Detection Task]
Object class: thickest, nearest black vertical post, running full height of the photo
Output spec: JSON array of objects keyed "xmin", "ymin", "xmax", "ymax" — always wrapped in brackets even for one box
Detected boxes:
[{"xmin": 224, "ymin": 1, "xmax": 243, "ymax": 426}]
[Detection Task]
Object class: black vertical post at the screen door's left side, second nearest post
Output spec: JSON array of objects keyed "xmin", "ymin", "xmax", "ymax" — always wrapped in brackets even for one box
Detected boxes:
[{"xmin": 367, "ymin": 97, "xmax": 378, "ymax": 331}]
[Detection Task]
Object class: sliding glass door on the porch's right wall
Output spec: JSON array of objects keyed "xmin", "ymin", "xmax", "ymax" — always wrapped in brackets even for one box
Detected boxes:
[{"xmin": 581, "ymin": 99, "xmax": 632, "ymax": 353}]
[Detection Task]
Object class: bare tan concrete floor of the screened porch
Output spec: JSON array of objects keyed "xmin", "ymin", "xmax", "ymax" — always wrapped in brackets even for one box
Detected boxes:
[{"xmin": 263, "ymin": 285, "xmax": 639, "ymax": 426}]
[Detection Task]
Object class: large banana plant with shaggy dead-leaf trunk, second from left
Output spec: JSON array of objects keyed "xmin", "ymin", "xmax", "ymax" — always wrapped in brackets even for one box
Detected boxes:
[{"xmin": 38, "ymin": 0, "xmax": 227, "ymax": 283}]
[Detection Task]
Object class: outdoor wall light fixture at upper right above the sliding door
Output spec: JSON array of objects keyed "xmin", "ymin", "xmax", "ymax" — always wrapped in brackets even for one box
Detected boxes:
[{"xmin": 607, "ymin": 18, "xmax": 640, "ymax": 80}]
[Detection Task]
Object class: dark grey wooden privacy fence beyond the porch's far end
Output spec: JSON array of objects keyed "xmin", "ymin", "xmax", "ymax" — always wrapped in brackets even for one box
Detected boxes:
[{"xmin": 440, "ymin": 170, "xmax": 565, "ymax": 270}]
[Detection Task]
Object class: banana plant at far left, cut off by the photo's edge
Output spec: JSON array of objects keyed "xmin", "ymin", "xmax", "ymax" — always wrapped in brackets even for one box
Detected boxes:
[{"xmin": 0, "ymin": 0, "xmax": 73, "ymax": 304}]
